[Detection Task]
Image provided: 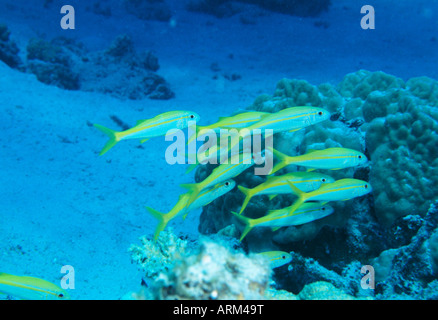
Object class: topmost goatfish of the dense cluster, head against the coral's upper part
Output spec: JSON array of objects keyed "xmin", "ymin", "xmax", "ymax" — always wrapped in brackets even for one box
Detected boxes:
[{"xmin": 240, "ymin": 106, "xmax": 330, "ymax": 134}]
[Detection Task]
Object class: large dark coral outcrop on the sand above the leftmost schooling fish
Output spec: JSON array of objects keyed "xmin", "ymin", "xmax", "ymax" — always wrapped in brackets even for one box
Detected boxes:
[{"xmin": 20, "ymin": 35, "xmax": 174, "ymax": 100}]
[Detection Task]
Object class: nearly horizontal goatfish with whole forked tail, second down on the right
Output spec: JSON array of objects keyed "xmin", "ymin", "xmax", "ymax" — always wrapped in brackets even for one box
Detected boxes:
[{"xmin": 271, "ymin": 148, "xmax": 368, "ymax": 174}]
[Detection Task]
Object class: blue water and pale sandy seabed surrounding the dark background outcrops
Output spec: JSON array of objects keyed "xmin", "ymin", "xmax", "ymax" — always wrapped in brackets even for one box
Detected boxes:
[{"xmin": 0, "ymin": 0, "xmax": 438, "ymax": 299}]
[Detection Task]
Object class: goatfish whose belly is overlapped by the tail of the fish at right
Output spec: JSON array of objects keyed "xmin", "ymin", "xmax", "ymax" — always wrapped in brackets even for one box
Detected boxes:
[{"xmin": 237, "ymin": 172, "xmax": 335, "ymax": 214}]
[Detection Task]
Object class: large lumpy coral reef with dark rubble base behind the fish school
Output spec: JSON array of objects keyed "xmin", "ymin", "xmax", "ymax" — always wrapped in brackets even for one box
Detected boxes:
[{"xmin": 195, "ymin": 70, "xmax": 438, "ymax": 299}]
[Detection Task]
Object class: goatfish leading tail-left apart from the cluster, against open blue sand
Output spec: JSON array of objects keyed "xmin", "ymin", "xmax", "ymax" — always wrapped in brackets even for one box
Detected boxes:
[{"xmin": 94, "ymin": 111, "xmax": 200, "ymax": 155}]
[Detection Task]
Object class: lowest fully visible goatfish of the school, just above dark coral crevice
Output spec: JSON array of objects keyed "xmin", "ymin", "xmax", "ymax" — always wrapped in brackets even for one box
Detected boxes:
[{"xmin": 232, "ymin": 202, "xmax": 334, "ymax": 241}]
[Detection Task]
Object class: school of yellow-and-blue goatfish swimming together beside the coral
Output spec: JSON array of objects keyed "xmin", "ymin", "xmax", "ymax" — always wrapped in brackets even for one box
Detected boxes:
[{"xmin": 95, "ymin": 106, "xmax": 372, "ymax": 267}]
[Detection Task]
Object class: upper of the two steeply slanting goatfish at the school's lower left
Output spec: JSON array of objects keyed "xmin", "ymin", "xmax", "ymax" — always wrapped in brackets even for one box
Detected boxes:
[{"xmin": 181, "ymin": 152, "xmax": 255, "ymax": 206}]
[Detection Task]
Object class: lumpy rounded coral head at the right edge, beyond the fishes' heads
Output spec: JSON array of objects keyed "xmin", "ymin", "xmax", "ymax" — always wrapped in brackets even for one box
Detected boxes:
[{"xmin": 362, "ymin": 77, "xmax": 438, "ymax": 225}]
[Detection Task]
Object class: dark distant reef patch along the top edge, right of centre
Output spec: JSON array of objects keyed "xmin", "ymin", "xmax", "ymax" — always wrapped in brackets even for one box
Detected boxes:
[{"xmin": 187, "ymin": 0, "xmax": 330, "ymax": 19}]
